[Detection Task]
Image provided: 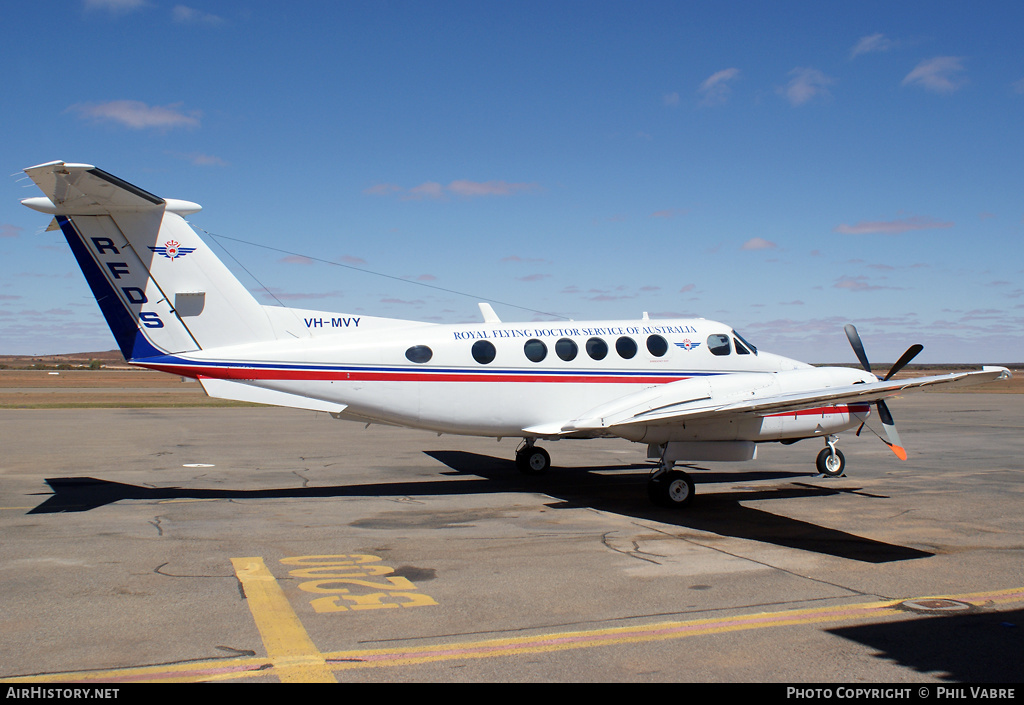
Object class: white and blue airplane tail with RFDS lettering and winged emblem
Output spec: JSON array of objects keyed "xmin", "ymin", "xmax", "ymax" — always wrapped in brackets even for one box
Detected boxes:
[{"xmin": 22, "ymin": 162, "xmax": 275, "ymax": 360}]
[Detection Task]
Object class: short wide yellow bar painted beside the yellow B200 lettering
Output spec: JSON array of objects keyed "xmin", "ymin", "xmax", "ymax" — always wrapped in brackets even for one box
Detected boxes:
[{"xmin": 231, "ymin": 557, "xmax": 337, "ymax": 682}]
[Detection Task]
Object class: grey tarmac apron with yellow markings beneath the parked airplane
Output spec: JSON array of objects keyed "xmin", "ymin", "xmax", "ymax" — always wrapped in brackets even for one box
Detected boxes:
[{"xmin": 0, "ymin": 393, "xmax": 1024, "ymax": 683}]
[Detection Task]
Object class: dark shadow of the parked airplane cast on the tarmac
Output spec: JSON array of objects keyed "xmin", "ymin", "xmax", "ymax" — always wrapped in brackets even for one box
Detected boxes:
[{"xmin": 29, "ymin": 451, "xmax": 933, "ymax": 564}]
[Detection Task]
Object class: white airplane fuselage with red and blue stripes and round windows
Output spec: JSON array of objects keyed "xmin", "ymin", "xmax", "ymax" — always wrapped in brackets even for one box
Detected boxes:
[{"xmin": 142, "ymin": 317, "xmax": 867, "ymax": 443}]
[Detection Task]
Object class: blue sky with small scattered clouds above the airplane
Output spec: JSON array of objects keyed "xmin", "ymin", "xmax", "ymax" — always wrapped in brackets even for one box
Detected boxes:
[{"xmin": 0, "ymin": 0, "xmax": 1024, "ymax": 363}]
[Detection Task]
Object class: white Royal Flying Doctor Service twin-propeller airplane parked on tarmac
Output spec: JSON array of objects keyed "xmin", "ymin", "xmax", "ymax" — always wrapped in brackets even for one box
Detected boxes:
[{"xmin": 22, "ymin": 161, "xmax": 1011, "ymax": 508}]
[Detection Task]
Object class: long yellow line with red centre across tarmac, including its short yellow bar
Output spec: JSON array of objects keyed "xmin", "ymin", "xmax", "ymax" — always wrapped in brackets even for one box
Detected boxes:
[{"xmin": 0, "ymin": 582, "xmax": 1024, "ymax": 683}]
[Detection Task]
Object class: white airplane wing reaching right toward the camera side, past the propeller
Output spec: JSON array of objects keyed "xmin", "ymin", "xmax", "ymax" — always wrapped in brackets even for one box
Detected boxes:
[{"xmin": 523, "ymin": 367, "xmax": 1011, "ymax": 436}]
